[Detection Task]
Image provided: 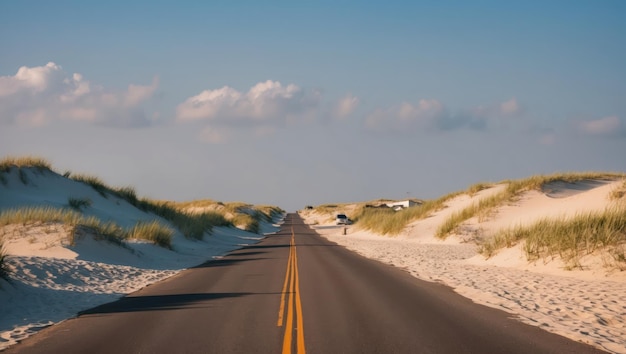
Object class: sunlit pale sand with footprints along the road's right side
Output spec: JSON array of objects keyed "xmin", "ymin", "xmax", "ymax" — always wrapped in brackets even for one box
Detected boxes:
[{"xmin": 302, "ymin": 182, "xmax": 626, "ymax": 353}]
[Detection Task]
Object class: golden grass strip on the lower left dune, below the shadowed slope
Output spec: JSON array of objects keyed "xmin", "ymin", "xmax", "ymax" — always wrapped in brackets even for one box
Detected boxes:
[{"xmin": 0, "ymin": 207, "xmax": 174, "ymax": 248}]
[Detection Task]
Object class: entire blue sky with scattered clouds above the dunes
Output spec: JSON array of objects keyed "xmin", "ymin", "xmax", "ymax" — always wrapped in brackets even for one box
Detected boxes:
[{"xmin": 0, "ymin": 1, "xmax": 626, "ymax": 210}]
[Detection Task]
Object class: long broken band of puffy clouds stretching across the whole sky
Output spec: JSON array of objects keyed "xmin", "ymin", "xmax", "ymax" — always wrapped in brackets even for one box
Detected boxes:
[{"xmin": 0, "ymin": 62, "xmax": 626, "ymax": 144}]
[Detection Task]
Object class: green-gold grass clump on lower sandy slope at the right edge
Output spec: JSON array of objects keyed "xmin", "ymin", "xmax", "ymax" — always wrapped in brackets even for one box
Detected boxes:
[{"xmin": 480, "ymin": 205, "xmax": 626, "ymax": 268}]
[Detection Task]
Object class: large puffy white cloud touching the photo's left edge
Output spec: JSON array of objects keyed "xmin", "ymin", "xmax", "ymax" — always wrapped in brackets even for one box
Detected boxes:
[{"xmin": 0, "ymin": 62, "xmax": 158, "ymax": 126}]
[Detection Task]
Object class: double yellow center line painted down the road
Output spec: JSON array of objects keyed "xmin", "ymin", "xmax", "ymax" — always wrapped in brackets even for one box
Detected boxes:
[{"xmin": 277, "ymin": 227, "xmax": 306, "ymax": 354}]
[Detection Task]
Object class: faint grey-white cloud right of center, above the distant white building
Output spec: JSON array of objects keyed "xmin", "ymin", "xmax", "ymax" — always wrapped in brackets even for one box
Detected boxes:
[{"xmin": 365, "ymin": 99, "xmax": 447, "ymax": 132}]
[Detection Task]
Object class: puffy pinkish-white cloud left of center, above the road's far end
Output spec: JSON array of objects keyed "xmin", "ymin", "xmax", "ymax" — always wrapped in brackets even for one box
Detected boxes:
[{"xmin": 176, "ymin": 80, "xmax": 321, "ymax": 143}]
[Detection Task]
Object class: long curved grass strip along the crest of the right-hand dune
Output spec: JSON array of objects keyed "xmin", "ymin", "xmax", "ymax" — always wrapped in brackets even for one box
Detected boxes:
[{"xmin": 435, "ymin": 172, "xmax": 624, "ymax": 239}]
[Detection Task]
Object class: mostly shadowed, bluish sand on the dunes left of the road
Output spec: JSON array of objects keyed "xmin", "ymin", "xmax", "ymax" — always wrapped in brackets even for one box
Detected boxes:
[{"xmin": 0, "ymin": 169, "xmax": 279, "ymax": 350}]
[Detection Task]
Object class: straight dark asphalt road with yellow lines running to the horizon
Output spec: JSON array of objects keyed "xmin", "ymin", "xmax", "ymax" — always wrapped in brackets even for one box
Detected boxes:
[{"xmin": 6, "ymin": 214, "xmax": 601, "ymax": 353}]
